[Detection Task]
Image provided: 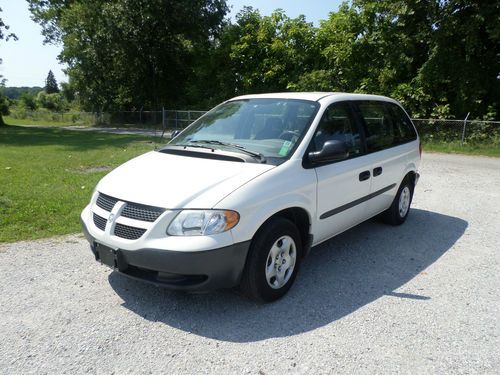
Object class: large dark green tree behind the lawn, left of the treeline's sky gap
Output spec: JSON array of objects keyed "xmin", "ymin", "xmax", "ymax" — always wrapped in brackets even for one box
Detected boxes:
[{"xmin": 28, "ymin": 0, "xmax": 228, "ymax": 110}]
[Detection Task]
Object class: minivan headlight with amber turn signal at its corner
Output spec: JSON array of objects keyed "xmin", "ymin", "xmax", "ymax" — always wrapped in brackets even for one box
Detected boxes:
[{"xmin": 167, "ymin": 210, "xmax": 240, "ymax": 236}]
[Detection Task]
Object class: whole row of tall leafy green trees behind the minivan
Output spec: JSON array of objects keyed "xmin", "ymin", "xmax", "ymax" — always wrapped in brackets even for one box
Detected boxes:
[{"xmin": 28, "ymin": 0, "xmax": 500, "ymax": 119}]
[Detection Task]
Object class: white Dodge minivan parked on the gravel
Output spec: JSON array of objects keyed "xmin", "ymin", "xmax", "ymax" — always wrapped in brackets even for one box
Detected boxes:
[{"xmin": 81, "ymin": 92, "xmax": 421, "ymax": 302}]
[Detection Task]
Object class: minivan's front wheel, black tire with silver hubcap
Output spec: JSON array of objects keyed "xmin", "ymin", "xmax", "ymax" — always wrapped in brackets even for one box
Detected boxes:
[{"xmin": 240, "ymin": 217, "xmax": 302, "ymax": 302}]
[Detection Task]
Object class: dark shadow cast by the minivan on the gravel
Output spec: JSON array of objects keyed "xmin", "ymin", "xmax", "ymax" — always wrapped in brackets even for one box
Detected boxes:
[{"xmin": 109, "ymin": 209, "xmax": 467, "ymax": 342}]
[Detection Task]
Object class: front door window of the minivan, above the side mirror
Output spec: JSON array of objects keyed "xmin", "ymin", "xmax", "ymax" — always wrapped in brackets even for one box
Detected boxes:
[{"xmin": 312, "ymin": 103, "xmax": 362, "ymax": 158}]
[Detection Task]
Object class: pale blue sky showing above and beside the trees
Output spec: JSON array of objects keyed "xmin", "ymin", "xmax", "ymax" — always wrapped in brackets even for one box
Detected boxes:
[{"xmin": 0, "ymin": 0, "xmax": 342, "ymax": 87}]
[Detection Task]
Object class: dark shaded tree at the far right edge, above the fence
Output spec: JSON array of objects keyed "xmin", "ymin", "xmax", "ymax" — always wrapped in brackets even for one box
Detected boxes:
[{"xmin": 416, "ymin": 0, "xmax": 500, "ymax": 118}]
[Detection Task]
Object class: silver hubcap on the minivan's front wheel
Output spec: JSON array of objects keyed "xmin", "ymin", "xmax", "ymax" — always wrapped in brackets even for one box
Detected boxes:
[{"xmin": 266, "ymin": 236, "xmax": 297, "ymax": 289}]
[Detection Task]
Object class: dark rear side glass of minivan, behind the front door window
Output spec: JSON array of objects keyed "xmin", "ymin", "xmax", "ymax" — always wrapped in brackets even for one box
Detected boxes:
[{"xmin": 357, "ymin": 101, "xmax": 417, "ymax": 152}]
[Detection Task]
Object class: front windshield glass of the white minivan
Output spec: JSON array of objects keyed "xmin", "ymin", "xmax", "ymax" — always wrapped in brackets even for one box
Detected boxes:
[{"xmin": 169, "ymin": 99, "xmax": 319, "ymax": 159}]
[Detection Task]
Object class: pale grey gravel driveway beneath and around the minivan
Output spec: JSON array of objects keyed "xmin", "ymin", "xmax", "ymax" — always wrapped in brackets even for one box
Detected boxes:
[{"xmin": 0, "ymin": 154, "xmax": 500, "ymax": 374}]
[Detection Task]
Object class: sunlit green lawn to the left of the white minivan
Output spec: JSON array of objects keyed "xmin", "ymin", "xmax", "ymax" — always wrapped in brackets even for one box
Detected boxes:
[{"xmin": 0, "ymin": 126, "xmax": 160, "ymax": 242}]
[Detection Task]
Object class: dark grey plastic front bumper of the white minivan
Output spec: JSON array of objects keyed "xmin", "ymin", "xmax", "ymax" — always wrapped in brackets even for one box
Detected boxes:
[{"xmin": 81, "ymin": 216, "xmax": 250, "ymax": 291}]
